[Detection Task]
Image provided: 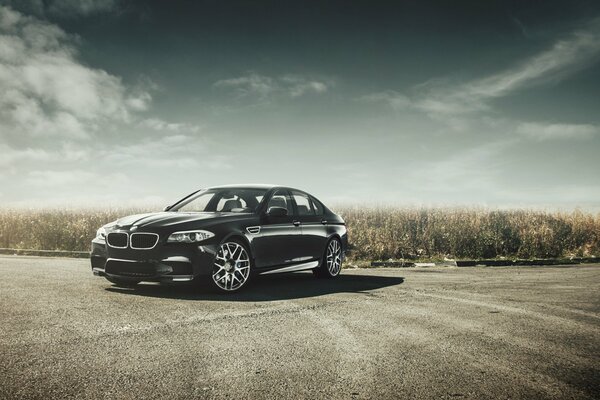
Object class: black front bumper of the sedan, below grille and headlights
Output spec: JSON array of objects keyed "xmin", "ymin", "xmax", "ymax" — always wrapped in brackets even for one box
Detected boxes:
[{"xmin": 90, "ymin": 239, "xmax": 218, "ymax": 282}]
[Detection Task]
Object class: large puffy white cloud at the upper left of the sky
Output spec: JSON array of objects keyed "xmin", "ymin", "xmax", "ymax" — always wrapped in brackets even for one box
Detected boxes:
[{"xmin": 0, "ymin": 6, "xmax": 151, "ymax": 139}]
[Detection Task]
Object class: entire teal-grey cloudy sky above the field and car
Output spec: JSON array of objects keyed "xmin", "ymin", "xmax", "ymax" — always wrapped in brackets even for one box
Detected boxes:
[{"xmin": 0, "ymin": 0, "xmax": 600, "ymax": 211}]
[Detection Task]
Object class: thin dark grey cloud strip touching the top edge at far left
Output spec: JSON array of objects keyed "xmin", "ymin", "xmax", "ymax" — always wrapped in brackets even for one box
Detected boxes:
[{"xmin": 2, "ymin": 0, "xmax": 118, "ymax": 18}]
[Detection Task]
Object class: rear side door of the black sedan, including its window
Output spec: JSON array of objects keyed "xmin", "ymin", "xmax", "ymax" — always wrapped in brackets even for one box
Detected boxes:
[{"xmin": 291, "ymin": 190, "xmax": 327, "ymax": 260}]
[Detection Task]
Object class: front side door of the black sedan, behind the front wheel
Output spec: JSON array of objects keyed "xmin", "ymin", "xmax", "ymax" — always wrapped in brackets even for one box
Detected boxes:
[{"xmin": 252, "ymin": 189, "xmax": 302, "ymax": 269}]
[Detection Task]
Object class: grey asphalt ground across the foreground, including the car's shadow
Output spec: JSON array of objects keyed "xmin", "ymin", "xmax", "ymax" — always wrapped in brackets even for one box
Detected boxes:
[{"xmin": 0, "ymin": 257, "xmax": 600, "ymax": 399}]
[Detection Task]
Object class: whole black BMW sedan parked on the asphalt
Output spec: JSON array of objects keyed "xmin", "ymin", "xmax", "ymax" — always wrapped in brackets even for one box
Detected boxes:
[{"xmin": 91, "ymin": 185, "xmax": 348, "ymax": 292}]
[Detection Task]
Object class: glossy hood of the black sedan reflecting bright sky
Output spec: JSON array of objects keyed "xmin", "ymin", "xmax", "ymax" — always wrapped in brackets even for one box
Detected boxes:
[{"xmin": 116, "ymin": 212, "xmax": 251, "ymax": 229}]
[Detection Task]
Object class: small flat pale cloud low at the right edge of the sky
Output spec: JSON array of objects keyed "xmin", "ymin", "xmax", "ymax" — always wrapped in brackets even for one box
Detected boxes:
[{"xmin": 516, "ymin": 122, "xmax": 600, "ymax": 141}]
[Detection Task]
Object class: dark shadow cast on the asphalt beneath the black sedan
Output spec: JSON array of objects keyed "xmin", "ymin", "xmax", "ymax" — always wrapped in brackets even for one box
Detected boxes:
[{"xmin": 106, "ymin": 272, "xmax": 404, "ymax": 301}]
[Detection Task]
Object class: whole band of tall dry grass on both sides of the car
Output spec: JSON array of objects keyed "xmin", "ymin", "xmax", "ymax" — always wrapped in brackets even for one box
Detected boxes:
[{"xmin": 0, "ymin": 207, "xmax": 600, "ymax": 260}]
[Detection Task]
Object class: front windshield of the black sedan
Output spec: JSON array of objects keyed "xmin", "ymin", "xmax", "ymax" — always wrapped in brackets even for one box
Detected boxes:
[{"xmin": 169, "ymin": 188, "xmax": 267, "ymax": 213}]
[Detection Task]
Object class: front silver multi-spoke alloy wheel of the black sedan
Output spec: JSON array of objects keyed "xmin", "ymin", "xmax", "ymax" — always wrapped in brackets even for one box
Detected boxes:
[{"xmin": 212, "ymin": 242, "xmax": 250, "ymax": 292}]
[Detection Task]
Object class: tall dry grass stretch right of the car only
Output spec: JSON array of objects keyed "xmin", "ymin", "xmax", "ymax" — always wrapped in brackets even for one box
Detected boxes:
[{"xmin": 338, "ymin": 207, "xmax": 600, "ymax": 260}]
